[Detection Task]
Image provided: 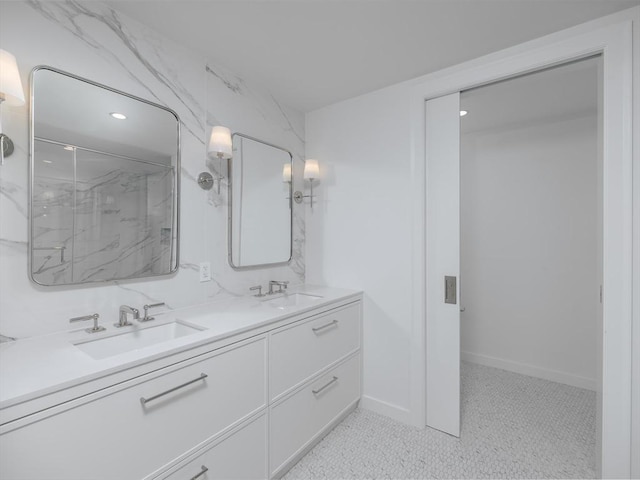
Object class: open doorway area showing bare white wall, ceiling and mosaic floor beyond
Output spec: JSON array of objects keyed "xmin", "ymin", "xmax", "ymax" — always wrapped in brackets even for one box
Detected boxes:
[{"xmin": 459, "ymin": 56, "xmax": 602, "ymax": 478}]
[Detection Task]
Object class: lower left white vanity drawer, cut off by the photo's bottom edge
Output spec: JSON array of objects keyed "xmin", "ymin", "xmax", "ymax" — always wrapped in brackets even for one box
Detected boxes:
[{"xmin": 159, "ymin": 415, "xmax": 268, "ymax": 480}]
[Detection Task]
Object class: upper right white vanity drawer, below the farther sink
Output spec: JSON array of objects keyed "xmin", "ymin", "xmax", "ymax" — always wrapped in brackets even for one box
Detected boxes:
[{"xmin": 269, "ymin": 303, "xmax": 360, "ymax": 399}]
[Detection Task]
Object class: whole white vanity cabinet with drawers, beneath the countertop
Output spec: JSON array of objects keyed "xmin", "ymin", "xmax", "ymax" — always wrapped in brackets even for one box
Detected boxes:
[{"xmin": 0, "ymin": 294, "xmax": 362, "ymax": 480}]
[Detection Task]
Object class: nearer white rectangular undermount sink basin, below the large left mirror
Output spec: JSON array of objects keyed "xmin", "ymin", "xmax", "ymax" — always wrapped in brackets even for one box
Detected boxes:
[{"xmin": 74, "ymin": 320, "xmax": 204, "ymax": 360}]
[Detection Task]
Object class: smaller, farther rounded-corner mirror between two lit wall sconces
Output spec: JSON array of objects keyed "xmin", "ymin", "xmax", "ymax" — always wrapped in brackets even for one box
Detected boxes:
[{"xmin": 229, "ymin": 133, "xmax": 293, "ymax": 270}]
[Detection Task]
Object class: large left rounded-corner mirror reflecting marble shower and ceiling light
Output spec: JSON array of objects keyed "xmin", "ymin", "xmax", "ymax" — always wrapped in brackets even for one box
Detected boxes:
[{"xmin": 29, "ymin": 66, "xmax": 180, "ymax": 286}]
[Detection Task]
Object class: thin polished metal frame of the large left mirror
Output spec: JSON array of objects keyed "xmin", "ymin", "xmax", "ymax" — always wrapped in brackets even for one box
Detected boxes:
[{"xmin": 27, "ymin": 65, "xmax": 182, "ymax": 288}]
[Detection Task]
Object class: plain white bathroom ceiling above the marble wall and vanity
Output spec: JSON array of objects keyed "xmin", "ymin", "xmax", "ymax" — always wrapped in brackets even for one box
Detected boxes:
[{"xmin": 106, "ymin": 0, "xmax": 640, "ymax": 112}]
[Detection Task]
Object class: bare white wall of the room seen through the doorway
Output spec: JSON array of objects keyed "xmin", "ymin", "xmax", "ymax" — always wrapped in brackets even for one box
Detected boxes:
[{"xmin": 460, "ymin": 115, "xmax": 600, "ymax": 390}]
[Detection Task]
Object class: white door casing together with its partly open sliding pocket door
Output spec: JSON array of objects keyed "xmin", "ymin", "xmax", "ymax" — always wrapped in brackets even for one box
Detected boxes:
[{"xmin": 422, "ymin": 22, "xmax": 637, "ymax": 478}]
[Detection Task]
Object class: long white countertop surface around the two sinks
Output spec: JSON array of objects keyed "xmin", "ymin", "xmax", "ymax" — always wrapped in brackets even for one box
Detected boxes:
[{"xmin": 0, "ymin": 285, "xmax": 361, "ymax": 416}]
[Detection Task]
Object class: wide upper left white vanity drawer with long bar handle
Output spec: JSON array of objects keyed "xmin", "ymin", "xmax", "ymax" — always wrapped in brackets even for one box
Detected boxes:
[{"xmin": 0, "ymin": 338, "xmax": 266, "ymax": 480}]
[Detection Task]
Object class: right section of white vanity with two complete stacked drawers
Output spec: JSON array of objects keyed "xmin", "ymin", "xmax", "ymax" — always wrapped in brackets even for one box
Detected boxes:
[{"xmin": 269, "ymin": 302, "xmax": 362, "ymax": 477}]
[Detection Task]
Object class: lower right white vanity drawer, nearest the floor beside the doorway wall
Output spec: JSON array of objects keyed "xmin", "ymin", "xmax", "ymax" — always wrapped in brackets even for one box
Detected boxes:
[{"xmin": 269, "ymin": 354, "xmax": 360, "ymax": 475}]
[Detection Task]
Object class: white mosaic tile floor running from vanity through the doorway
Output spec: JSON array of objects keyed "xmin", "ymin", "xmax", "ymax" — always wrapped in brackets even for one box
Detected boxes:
[{"xmin": 283, "ymin": 363, "xmax": 596, "ymax": 480}]
